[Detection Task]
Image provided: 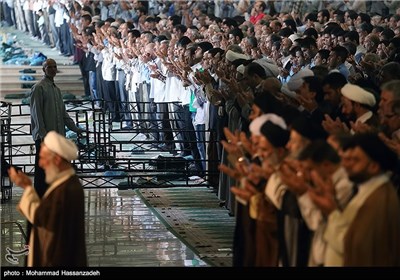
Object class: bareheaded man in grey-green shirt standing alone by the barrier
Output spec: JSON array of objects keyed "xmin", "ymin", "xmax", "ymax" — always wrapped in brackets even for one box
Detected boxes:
[{"xmin": 30, "ymin": 59, "xmax": 83, "ymax": 197}]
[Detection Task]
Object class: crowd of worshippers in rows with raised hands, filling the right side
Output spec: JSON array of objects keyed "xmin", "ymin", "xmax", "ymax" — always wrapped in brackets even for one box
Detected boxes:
[{"xmin": 7, "ymin": 1, "xmax": 400, "ymax": 266}]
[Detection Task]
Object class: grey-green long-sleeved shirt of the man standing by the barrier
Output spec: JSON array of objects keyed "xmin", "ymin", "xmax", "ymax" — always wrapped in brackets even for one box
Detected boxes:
[{"xmin": 30, "ymin": 77, "xmax": 78, "ymax": 141}]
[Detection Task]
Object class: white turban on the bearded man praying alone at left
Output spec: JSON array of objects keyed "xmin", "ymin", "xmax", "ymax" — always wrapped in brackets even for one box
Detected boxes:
[{"xmin": 43, "ymin": 131, "xmax": 78, "ymax": 161}]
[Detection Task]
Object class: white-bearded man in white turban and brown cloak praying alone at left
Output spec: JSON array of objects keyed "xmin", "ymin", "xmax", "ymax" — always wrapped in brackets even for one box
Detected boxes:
[{"xmin": 9, "ymin": 131, "xmax": 87, "ymax": 267}]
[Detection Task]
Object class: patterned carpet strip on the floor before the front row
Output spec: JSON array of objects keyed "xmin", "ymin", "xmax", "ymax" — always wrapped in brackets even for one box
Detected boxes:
[{"xmin": 135, "ymin": 187, "xmax": 235, "ymax": 267}]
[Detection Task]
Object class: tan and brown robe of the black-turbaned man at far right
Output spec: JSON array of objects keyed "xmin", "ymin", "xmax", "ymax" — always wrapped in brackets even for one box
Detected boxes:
[{"xmin": 324, "ymin": 174, "xmax": 400, "ymax": 266}]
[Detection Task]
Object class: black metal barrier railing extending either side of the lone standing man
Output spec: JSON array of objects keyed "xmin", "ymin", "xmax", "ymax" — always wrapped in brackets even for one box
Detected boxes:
[{"xmin": 2, "ymin": 100, "xmax": 218, "ymax": 195}]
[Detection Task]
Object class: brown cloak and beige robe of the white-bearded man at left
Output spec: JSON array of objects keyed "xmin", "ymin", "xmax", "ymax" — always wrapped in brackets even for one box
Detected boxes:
[{"xmin": 18, "ymin": 169, "xmax": 87, "ymax": 267}]
